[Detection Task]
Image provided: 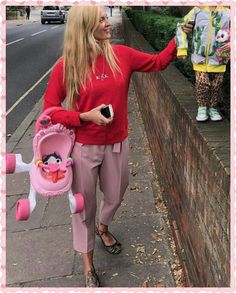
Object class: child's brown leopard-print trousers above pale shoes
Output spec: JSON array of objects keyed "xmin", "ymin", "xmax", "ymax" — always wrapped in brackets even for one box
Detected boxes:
[{"xmin": 195, "ymin": 71, "xmax": 224, "ymax": 108}]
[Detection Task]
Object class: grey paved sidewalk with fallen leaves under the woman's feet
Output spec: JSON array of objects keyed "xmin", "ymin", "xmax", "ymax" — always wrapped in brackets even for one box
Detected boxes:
[{"xmin": 6, "ymin": 8, "xmax": 185, "ymax": 287}]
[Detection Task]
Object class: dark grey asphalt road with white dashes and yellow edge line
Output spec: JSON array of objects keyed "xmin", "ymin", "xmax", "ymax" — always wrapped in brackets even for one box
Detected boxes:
[{"xmin": 6, "ymin": 20, "xmax": 65, "ymax": 134}]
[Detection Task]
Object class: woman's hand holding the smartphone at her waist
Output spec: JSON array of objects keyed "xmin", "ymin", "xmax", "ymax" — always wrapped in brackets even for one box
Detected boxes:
[{"xmin": 80, "ymin": 104, "xmax": 113, "ymax": 126}]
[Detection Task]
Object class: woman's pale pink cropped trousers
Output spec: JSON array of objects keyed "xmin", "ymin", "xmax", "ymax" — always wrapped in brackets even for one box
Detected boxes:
[{"xmin": 72, "ymin": 139, "xmax": 129, "ymax": 253}]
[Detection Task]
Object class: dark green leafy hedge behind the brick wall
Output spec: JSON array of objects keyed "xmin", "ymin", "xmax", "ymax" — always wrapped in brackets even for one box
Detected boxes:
[{"xmin": 123, "ymin": 7, "xmax": 230, "ymax": 119}]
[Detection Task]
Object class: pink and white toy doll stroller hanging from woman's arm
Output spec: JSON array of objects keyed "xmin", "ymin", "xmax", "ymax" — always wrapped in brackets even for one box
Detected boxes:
[{"xmin": 6, "ymin": 107, "xmax": 84, "ymax": 221}]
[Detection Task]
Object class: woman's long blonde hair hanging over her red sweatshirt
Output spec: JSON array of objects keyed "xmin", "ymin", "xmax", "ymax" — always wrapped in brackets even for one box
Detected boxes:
[{"xmin": 63, "ymin": 6, "xmax": 120, "ymax": 109}]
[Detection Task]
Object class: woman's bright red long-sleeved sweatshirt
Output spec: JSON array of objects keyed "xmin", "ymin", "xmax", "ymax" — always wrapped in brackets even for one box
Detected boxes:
[{"xmin": 43, "ymin": 39, "xmax": 176, "ymax": 145}]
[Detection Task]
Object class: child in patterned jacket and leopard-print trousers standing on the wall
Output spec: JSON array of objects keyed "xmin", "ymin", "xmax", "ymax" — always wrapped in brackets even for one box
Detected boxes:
[{"xmin": 176, "ymin": 6, "xmax": 230, "ymax": 122}]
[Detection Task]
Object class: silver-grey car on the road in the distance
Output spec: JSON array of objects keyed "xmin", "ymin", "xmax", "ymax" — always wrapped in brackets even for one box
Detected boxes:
[{"xmin": 41, "ymin": 6, "xmax": 67, "ymax": 24}]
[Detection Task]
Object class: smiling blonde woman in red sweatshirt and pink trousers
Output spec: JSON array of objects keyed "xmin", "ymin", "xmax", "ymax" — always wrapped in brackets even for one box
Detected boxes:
[{"xmin": 44, "ymin": 6, "xmax": 176, "ymax": 287}]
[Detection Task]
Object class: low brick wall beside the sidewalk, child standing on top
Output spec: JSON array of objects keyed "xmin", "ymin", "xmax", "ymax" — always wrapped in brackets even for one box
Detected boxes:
[{"xmin": 123, "ymin": 16, "xmax": 230, "ymax": 287}]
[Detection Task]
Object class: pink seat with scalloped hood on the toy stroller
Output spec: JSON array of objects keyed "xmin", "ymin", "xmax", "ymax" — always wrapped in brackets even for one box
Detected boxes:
[{"xmin": 30, "ymin": 124, "xmax": 74, "ymax": 196}]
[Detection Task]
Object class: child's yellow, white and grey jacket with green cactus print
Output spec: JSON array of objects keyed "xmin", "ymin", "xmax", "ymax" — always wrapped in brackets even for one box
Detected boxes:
[{"xmin": 176, "ymin": 6, "xmax": 230, "ymax": 72}]
